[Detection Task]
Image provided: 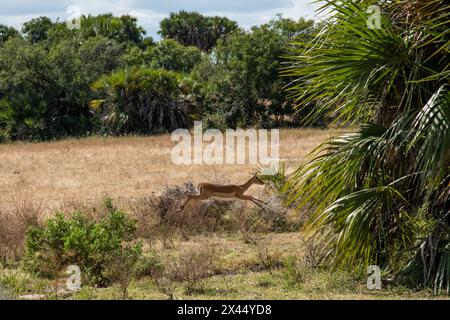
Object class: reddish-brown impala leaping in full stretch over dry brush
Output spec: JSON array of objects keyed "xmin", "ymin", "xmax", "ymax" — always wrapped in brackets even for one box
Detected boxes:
[{"xmin": 177, "ymin": 175, "xmax": 265, "ymax": 212}]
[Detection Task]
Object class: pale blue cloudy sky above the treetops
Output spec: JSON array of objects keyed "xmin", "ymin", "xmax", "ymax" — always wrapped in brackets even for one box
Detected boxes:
[{"xmin": 0, "ymin": 0, "xmax": 320, "ymax": 39}]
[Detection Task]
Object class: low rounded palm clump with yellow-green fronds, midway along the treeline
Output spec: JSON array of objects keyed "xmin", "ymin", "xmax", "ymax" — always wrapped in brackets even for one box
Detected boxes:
[{"xmin": 91, "ymin": 67, "xmax": 188, "ymax": 134}]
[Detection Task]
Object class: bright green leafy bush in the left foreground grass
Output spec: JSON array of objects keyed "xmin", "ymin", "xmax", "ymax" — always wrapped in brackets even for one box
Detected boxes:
[{"xmin": 24, "ymin": 201, "xmax": 141, "ymax": 286}]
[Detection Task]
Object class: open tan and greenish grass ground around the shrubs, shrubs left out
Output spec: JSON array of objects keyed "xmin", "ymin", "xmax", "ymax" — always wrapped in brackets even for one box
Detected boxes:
[{"xmin": 0, "ymin": 129, "xmax": 445, "ymax": 299}]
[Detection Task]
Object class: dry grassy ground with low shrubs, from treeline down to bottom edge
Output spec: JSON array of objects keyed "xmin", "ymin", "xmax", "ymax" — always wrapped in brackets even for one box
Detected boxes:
[{"xmin": 0, "ymin": 129, "xmax": 445, "ymax": 299}]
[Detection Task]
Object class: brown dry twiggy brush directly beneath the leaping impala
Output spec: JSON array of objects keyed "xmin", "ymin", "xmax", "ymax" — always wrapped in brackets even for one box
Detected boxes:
[{"xmin": 130, "ymin": 182, "xmax": 298, "ymax": 244}]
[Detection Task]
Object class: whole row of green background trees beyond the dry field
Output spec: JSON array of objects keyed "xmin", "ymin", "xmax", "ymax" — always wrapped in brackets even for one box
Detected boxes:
[{"xmin": 0, "ymin": 11, "xmax": 320, "ymax": 141}]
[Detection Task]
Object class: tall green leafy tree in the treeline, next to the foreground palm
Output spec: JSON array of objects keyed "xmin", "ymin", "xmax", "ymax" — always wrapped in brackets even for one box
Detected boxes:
[{"xmin": 194, "ymin": 16, "xmax": 314, "ymax": 127}]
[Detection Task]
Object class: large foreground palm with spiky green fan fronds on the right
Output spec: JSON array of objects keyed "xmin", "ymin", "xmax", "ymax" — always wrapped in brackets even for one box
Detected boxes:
[{"xmin": 284, "ymin": 0, "xmax": 450, "ymax": 292}]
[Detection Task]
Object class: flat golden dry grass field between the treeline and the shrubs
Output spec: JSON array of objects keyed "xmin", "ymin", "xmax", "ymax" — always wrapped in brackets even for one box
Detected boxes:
[{"xmin": 0, "ymin": 129, "xmax": 337, "ymax": 211}]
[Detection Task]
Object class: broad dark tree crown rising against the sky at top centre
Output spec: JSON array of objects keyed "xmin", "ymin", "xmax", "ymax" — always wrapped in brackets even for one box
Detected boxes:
[{"xmin": 159, "ymin": 11, "xmax": 237, "ymax": 51}]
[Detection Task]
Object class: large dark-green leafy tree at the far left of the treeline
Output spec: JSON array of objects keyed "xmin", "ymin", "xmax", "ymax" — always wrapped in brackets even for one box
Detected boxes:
[{"xmin": 0, "ymin": 37, "xmax": 122, "ymax": 139}]
